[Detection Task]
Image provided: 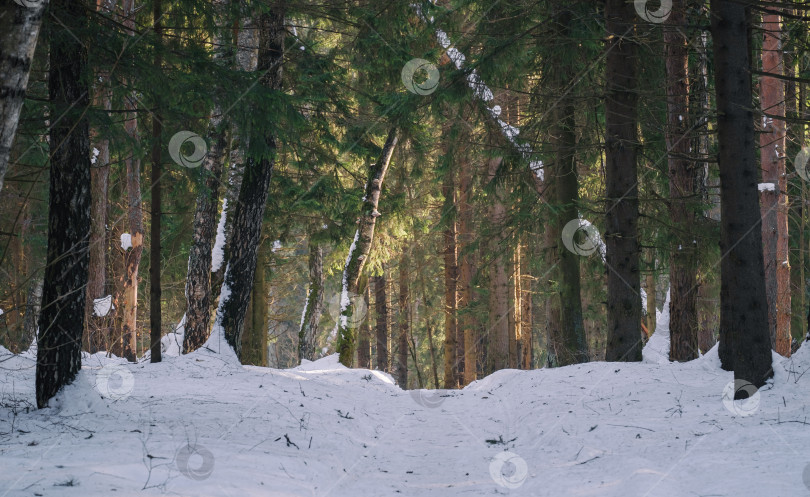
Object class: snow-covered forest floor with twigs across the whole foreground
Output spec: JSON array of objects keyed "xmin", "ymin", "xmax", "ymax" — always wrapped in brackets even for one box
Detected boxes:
[{"xmin": 0, "ymin": 328, "xmax": 810, "ymax": 497}]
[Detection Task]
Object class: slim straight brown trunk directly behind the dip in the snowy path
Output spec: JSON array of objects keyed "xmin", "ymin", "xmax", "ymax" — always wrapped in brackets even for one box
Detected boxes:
[{"xmin": 442, "ymin": 170, "xmax": 459, "ymax": 388}]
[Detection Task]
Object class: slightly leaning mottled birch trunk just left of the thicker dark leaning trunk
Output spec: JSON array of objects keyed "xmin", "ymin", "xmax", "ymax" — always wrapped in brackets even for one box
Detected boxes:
[{"xmin": 183, "ymin": 0, "xmax": 228, "ymax": 354}]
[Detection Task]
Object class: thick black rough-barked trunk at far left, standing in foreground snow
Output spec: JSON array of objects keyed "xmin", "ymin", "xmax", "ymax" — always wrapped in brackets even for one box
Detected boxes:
[{"xmin": 36, "ymin": 0, "xmax": 90, "ymax": 408}]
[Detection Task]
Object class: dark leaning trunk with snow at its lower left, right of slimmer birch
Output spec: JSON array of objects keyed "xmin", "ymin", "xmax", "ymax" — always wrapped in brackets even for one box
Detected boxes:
[{"xmin": 215, "ymin": 6, "xmax": 285, "ymax": 357}]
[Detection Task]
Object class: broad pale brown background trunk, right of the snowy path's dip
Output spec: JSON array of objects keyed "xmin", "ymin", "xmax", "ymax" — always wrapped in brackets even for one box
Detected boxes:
[{"xmin": 486, "ymin": 157, "xmax": 504, "ymax": 374}]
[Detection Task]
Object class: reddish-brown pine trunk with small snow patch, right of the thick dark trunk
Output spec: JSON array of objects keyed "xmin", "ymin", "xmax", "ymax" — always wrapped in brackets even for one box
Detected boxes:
[{"xmin": 759, "ymin": 9, "xmax": 790, "ymax": 357}]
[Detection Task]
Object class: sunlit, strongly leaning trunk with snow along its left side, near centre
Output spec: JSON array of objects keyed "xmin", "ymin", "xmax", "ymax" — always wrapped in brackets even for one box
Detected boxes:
[{"xmin": 336, "ymin": 128, "xmax": 399, "ymax": 367}]
